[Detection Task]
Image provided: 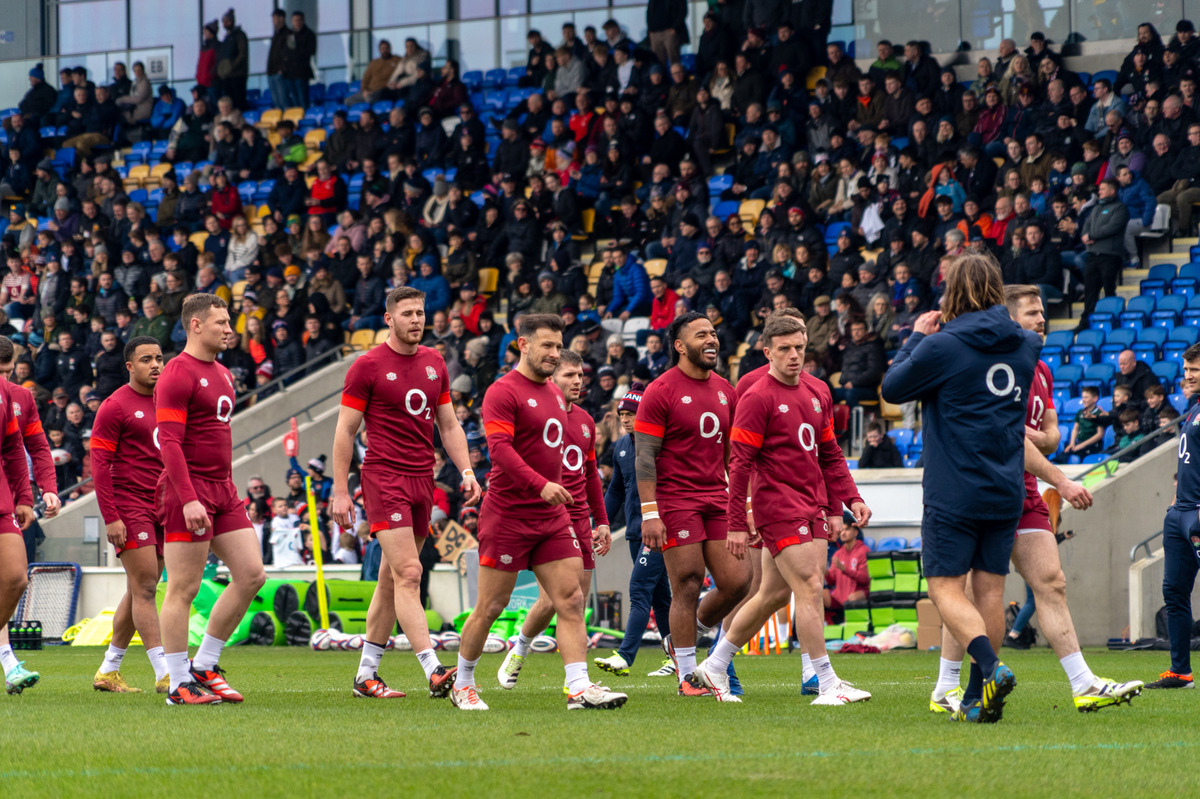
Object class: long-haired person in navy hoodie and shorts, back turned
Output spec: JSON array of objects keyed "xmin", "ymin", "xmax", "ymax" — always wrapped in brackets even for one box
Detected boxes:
[{"xmin": 882, "ymin": 253, "xmax": 1042, "ymax": 722}]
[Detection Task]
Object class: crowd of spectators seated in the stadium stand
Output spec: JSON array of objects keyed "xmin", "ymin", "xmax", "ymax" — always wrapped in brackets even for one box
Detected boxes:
[{"xmin": 9, "ymin": 0, "xmax": 1200, "ymax": 548}]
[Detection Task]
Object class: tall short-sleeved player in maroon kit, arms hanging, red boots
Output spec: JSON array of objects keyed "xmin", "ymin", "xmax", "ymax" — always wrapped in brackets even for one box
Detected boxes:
[{"xmin": 331, "ymin": 286, "xmax": 480, "ymax": 699}]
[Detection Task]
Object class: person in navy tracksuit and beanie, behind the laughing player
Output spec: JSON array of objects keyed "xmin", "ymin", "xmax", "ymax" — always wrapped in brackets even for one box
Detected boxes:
[{"xmin": 598, "ymin": 389, "xmax": 671, "ymax": 671}]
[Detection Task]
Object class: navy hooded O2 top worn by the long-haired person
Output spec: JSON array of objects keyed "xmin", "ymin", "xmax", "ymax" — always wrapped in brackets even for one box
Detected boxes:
[{"xmin": 882, "ymin": 305, "xmax": 1042, "ymax": 519}]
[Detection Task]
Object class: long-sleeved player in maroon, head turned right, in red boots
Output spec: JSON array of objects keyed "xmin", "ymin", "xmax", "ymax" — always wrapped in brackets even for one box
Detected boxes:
[{"xmin": 154, "ymin": 294, "xmax": 266, "ymax": 704}]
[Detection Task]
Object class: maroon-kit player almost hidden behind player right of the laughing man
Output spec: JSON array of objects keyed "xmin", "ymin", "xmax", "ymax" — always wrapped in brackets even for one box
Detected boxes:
[{"xmin": 724, "ymin": 308, "xmax": 842, "ymax": 696}]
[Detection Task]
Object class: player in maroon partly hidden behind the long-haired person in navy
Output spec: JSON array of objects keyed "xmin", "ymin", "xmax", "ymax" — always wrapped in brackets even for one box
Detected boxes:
[{"xmin": 929, "ymin": 286, "xmax": 1142, "ymax": 714}]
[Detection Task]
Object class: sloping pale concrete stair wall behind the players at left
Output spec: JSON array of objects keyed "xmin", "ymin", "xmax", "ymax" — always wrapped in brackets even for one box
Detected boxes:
[{"xmin": 41, "ymin": 356, "xmax": 355, "ymax": 566}]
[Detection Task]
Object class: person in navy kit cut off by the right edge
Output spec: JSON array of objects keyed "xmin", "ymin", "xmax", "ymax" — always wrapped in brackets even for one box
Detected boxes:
[{"xmin": 1146, "ymin": 344, "xmax": 1200, "ymax": 689}]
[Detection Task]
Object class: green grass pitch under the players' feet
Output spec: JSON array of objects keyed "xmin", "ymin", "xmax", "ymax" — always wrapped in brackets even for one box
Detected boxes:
[{"xmin": 0, "ymin": 647, "xmax": 1200, "ymax": 799}]
